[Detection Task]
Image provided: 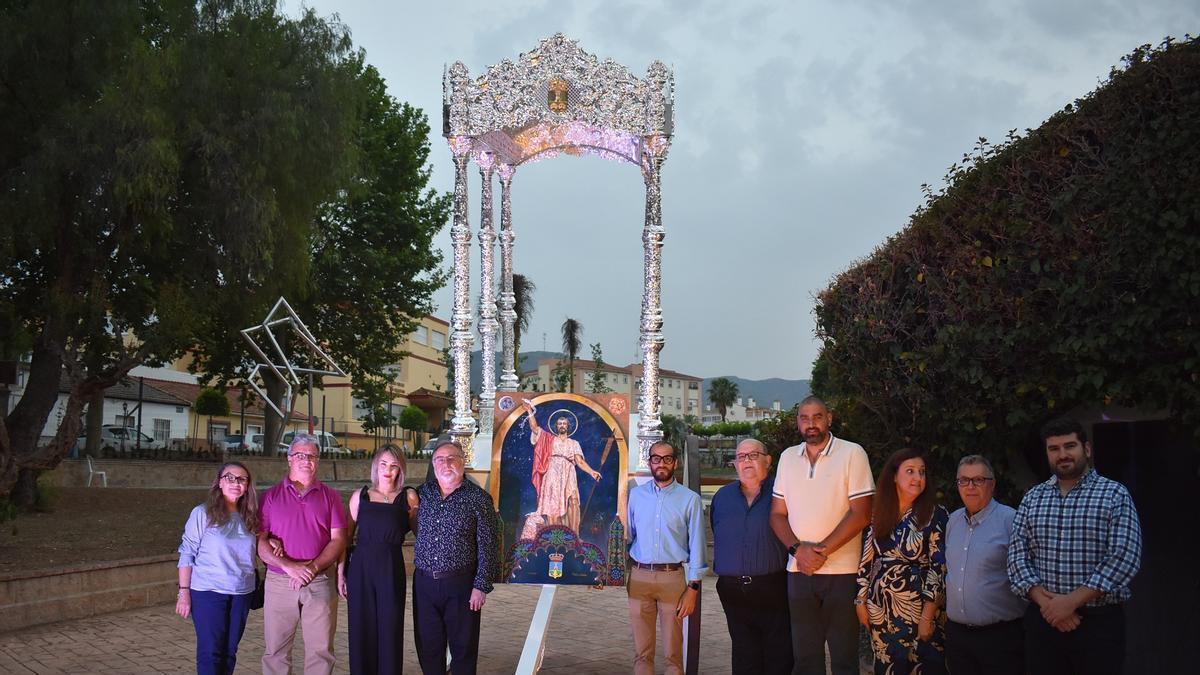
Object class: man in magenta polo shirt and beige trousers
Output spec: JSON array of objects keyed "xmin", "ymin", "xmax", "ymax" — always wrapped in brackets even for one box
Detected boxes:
[{"xmin": 258, "ymin": 434, "xmax": 347, "ymax": 674}]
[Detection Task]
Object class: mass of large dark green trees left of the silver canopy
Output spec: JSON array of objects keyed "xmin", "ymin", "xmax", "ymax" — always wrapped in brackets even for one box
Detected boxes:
[{"xmin": 0, "ymin": 0, "xmax": 449, "ymax": 503}]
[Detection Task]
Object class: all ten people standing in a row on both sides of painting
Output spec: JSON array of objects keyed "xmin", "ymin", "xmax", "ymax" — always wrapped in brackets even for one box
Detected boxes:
[{"xmin": 176, "ymin": 396, "xmax": 1141, "ymax": 675}]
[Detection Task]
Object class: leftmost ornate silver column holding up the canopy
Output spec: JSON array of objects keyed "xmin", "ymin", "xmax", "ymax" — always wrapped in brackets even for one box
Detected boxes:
[{"xmin": 450, "ymin": 136, "xmax": 475, "ymax": 456}]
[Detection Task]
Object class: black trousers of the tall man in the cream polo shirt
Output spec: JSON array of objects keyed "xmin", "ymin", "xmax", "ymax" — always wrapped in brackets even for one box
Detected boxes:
[{"xmin": 787, "ymin": 572, "xmax": 859, "ymax": 675}]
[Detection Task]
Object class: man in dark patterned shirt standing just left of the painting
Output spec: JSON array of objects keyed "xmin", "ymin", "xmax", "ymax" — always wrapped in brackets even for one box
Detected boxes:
[{"xmin": 413, "ymin": 442, "xmax": 498, "ymax": 675}]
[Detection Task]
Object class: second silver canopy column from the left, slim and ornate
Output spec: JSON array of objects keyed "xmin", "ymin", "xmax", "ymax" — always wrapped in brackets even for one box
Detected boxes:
[{"xmin": 475, "ymin": 153, "xmax": 499, "ymax": 436}]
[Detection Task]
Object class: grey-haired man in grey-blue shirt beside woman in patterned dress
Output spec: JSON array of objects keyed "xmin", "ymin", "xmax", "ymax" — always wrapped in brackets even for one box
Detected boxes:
[{"xmin": 946, "ymin": 455, "xmax": 1026, "ymax": 675}]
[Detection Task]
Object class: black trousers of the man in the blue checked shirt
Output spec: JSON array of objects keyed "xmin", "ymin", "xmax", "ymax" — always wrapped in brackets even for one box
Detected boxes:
[{"xmin": 1025, "ymin": 603, "xmax": 1124, "ymax": 675}]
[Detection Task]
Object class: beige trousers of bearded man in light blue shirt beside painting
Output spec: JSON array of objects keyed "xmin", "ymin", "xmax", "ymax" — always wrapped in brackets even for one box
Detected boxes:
[{"xmin": 626, "ymin": 567, "xmax": 688, "ymax": 675}]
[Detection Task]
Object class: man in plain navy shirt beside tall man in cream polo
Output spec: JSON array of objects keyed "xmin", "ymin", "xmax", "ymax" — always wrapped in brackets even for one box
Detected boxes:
[{"xmin": 709, "ymin": 438, "xmax": 792, "ymax": 675}]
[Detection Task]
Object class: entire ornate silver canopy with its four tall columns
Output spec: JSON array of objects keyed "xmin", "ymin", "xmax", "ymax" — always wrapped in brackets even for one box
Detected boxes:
[{"xmin": 442, "ymin": 34, "xmax": 674, "ymax": 462}]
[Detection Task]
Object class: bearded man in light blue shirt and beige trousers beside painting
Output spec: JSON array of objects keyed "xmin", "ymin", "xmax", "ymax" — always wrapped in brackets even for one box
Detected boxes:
[{"xmin": 626, "ymin": 442, "xmax": 708, "ymax": 675}]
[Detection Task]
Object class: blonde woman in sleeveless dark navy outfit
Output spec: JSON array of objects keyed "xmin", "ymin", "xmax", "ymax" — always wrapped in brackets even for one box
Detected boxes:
[{"xmin": 337, "ymin": 444, "xmax": 418, "ymax": 675}]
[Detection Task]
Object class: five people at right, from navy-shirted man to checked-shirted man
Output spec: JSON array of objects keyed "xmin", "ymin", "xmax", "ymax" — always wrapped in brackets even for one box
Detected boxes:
[{"xmin": 700, "ymin": 396, "xmax": 1141, "ymax": 675}]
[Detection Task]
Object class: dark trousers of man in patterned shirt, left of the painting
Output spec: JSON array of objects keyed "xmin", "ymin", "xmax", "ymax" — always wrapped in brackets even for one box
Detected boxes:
[{"xmin": 413, "ymin": 569, "xmax": 481, "ymax": 675}]
